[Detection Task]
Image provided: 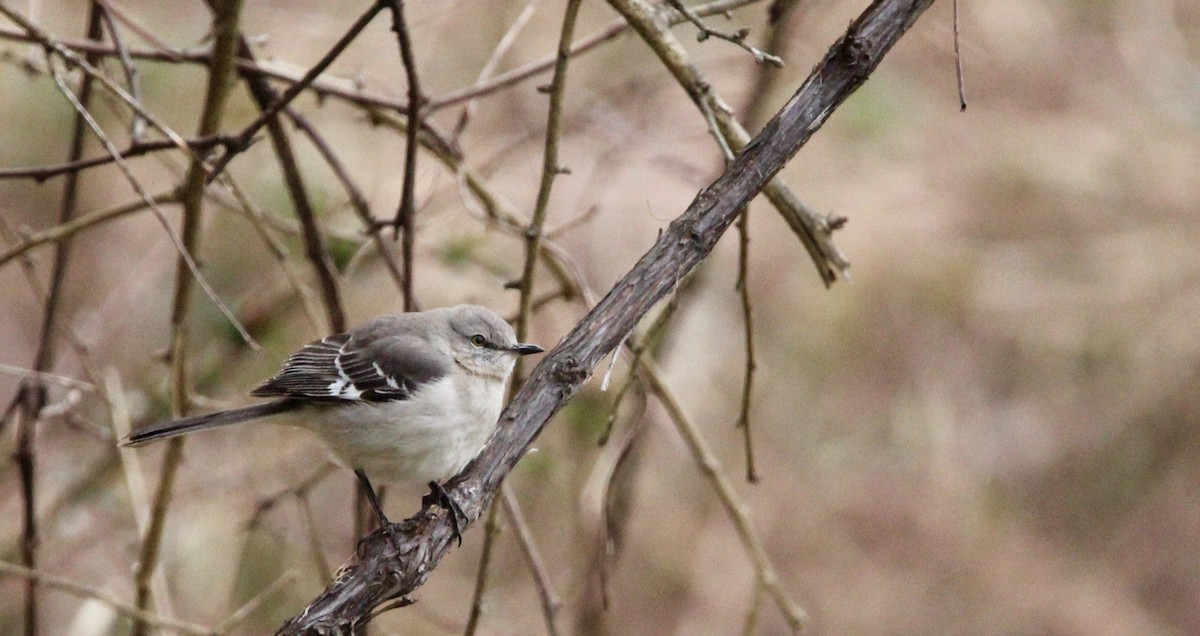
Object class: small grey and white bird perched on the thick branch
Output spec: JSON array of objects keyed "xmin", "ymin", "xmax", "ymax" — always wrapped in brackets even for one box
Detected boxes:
[{"xmin": 121, "ymin": 305, "xmax": 545, "ymax": 544}]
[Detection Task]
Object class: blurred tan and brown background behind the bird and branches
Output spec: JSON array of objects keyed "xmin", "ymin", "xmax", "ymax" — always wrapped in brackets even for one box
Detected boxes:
[{"xmin": 0, "ymin": 0, "xmax": 1200, "ymax": 635}]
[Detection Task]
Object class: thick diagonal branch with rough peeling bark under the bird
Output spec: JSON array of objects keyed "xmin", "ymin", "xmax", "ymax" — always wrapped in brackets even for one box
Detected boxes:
[{"xmin": 280, "ymin": 0, "xmax": 932, "ymax": 634}]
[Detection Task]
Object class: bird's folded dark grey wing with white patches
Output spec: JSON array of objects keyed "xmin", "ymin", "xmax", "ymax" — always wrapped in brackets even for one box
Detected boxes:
[{"xmin": 251, "ymin": 330, "xmax": 454, "ymax": 402}]
